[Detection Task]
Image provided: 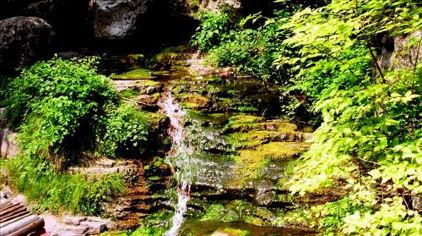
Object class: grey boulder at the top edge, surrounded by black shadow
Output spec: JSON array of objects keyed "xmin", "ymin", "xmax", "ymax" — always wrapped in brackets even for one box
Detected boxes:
[{"xmin": 91, "ymin": 0, "xmax": 151, "ymax": 40}]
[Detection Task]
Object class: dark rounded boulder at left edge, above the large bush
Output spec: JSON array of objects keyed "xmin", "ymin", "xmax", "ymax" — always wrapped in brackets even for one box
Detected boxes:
[{"xmin": 0, "ymin": 16, "xmax": 54, "ymax": 71}]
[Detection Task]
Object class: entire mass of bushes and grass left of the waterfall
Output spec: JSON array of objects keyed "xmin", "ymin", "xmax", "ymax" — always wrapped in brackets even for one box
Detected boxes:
[{"xmin": 0, "ymin": 58, "xmax": 154, "ymax": 214}]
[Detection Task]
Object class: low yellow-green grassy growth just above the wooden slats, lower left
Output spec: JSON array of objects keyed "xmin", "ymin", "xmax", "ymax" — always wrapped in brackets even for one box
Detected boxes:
[{"xmin": 4, "ymin": 156, "xmax": 125, "ymax": 215}]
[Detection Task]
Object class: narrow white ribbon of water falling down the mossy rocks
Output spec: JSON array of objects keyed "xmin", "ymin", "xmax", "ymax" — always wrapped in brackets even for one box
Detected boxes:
[{"xmin": 160, "ymin": 92, "xmax": 192, "ymax": 236}]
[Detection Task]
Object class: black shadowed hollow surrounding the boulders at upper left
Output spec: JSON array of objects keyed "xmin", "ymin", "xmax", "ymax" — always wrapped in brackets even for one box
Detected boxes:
[{"xmin": 0, "ymin": 0, "xmax": 198, "ymax": 53}]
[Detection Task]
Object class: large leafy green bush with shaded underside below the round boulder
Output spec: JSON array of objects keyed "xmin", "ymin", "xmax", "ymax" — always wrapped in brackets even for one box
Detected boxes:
[{"xmin": 5, "ymin": 58, "xmax": 118, "ymax": 164}]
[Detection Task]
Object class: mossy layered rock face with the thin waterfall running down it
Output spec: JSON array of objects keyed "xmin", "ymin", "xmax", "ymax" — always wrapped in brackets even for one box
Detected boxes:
[{"xmin": 109, "ymin": 50, "xmax": 314, "ymax": 236}]
